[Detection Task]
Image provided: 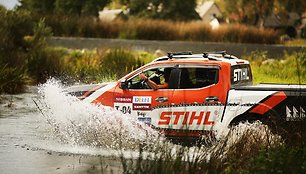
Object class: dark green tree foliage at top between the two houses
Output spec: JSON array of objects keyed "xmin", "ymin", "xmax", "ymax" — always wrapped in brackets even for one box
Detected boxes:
[{"xmin": 125, "ymin": 0, "xmax": 200, "ymax": 21}]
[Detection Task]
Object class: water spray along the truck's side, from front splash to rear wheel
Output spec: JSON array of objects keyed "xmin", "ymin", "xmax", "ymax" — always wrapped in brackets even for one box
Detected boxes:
[{"xmin": 34, "ymin": 79, "xmax": 282, "ymax": 161}]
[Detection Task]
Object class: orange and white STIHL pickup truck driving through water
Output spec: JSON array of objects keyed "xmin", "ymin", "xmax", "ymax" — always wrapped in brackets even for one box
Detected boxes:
[{"xmin": 68, "ymin": 52, "xmax": 306, "ymax": 140}]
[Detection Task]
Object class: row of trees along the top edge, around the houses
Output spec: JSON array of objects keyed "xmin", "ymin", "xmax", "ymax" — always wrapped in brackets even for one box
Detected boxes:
[{"xmin": 18, "ymin": 0, "xmax": 306, "ymax": 25}]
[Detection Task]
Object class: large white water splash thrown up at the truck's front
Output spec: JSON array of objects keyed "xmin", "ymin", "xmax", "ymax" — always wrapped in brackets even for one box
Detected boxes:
[{"xmin": 38, "ymin": 79, "xmax": 163, "ymax": 149}]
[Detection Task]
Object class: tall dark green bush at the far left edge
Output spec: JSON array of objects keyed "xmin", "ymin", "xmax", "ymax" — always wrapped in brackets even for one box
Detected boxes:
[{"xmin": 0, "ymin": 8, "xmax": 33, "ymax": 93}]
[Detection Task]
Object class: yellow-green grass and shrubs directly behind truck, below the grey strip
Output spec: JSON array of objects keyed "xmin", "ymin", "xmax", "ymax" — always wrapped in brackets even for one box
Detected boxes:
[{"xmin": 0, "ymin": 43, "xmax": 306, "ymax": 94}]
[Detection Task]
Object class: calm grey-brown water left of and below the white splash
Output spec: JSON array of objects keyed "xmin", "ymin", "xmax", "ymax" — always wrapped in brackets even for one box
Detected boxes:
[{"xmin": 0, "ymin": 93, "xmax": 121, "ymax": 174}]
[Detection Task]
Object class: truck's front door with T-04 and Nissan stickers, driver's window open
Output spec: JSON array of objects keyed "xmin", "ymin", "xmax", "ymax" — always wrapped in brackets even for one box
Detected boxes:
[{"xmin": 114, "ymin": 67, "xmax": 174, "ymax": 124}]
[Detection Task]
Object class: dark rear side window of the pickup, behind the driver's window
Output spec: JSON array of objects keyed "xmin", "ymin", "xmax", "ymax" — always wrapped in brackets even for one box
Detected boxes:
[{"xmin": 179, "ymin": 68, "xmax": 218, "ymax": 89}]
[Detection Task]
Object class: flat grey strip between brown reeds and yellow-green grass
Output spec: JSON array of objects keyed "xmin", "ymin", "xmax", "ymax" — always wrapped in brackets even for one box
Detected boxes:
[{"xmin": 48, "ymin": 37, "xmax": 305, "ymax": 58}]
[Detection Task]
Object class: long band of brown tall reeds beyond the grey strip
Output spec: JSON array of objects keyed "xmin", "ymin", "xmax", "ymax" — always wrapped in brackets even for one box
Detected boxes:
[{"xmin": 46, "ymin": 16, "xmax": 279, "ymax": 44}]
